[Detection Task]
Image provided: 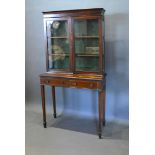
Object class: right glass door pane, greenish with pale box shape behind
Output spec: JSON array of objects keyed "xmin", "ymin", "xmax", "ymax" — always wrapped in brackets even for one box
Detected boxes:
[{"xmin": 74, "ymin": 19, "xmax": 99, "ymax": 71}]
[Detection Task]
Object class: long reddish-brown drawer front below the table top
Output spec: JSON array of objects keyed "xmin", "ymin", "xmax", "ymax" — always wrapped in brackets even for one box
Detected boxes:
[{"xmin": 41, "ymin": 79, "xmax": 101, "ymax": 89}]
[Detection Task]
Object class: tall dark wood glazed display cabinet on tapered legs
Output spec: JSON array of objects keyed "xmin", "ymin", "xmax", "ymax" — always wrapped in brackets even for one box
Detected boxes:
[{"xmin": 40, "ymin": 8, "xmax": 106, "ymax": 138}]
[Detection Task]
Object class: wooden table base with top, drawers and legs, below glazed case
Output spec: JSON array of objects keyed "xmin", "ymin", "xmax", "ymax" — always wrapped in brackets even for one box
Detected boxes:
[{"xmin": 40, "ymin": 72, "xmax": 105, "ymax": 138}]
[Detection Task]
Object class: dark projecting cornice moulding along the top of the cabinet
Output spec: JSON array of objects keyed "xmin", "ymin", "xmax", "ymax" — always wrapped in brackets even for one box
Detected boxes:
[{"xmin": 42, "ymin": 8, "xmax": 105, "ymax": 18}]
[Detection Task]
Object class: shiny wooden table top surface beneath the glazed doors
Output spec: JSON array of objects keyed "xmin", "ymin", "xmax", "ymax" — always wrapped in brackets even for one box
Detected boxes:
[{"xmin": 40, "ymin": 71, "xmax": 104, "ymax": 81}]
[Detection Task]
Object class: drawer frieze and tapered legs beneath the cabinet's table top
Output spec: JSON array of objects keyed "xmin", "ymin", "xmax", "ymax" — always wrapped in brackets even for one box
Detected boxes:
[{"xmin": 40, "ymin": 75, "xmax": 105, "ymax": 139}]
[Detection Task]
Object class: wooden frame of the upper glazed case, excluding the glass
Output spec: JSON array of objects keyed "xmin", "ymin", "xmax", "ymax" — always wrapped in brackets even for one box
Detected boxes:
[{"xmin": 43, "ymin": 8, "xmax": 105, "ymax": 74}]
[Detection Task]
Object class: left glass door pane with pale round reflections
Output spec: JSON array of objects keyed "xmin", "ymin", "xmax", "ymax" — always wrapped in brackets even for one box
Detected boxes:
[{"xmin": 48, "ymin": 21, "xmax": 69, "ymax": 69}]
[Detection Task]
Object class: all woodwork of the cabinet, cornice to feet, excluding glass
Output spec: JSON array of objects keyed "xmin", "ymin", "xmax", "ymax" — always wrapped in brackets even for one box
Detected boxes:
[{"xmin": 40, "ymin": 8, "xmax": 106, "ymax": 138}]
